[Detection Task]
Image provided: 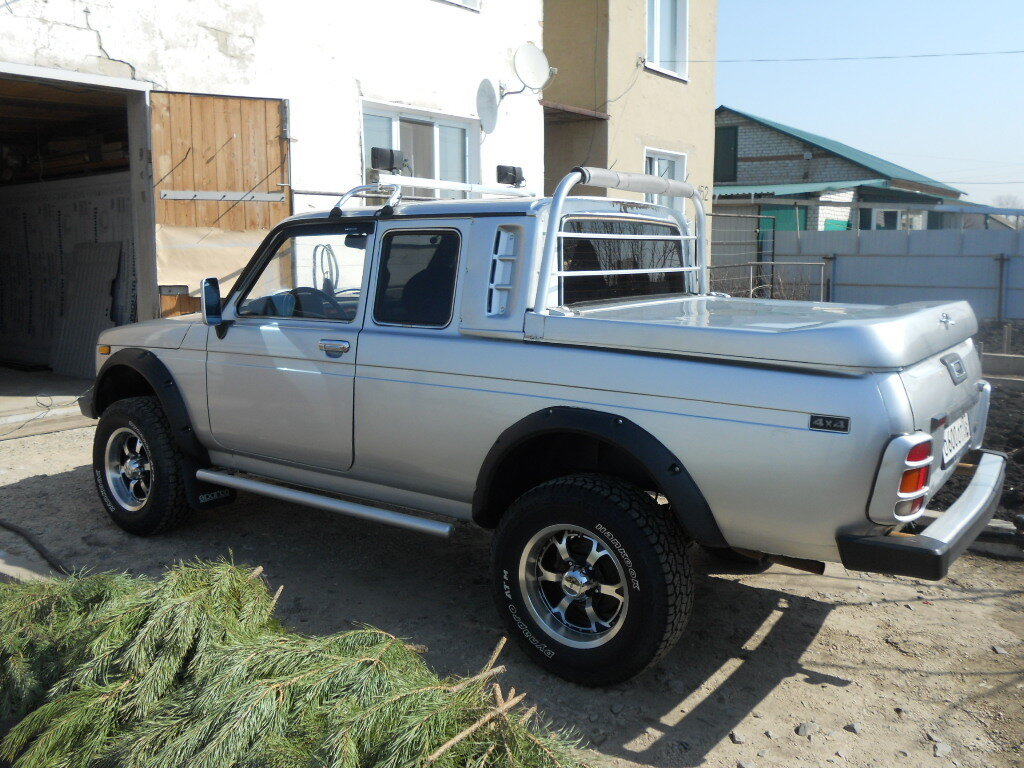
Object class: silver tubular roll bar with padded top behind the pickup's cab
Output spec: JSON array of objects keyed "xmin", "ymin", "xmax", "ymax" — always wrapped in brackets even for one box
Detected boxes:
[{"xmin": 534, "ymin": 167, "xmax": 708, "ymax": 314}]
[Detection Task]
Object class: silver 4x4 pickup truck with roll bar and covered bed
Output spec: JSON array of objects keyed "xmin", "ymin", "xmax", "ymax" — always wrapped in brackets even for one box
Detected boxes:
[{"xmin": 82, "ymin": 168, "xmax": 1005, "ymax": 685}]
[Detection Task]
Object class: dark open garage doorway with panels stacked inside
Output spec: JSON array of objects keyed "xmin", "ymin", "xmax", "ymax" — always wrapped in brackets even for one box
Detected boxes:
[{"xmin": 0, "ymin": 76, "xmax": 136, "ymax": 385}]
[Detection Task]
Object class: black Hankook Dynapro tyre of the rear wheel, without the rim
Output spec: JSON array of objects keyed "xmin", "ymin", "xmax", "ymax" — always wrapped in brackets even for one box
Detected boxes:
[{"xmin": 492, "ymin": 474, "xmax": 693, "ymax": 686}]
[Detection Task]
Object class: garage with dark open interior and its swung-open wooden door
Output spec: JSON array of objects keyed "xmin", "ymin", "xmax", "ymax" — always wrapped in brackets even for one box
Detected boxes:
[{"xmin": 0, "ymin": 68, "xmax": 291, "ymax": 438}]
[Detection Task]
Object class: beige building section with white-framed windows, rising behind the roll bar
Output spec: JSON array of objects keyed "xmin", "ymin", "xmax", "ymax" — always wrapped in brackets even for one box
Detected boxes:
[{"xmin": 542, "ymin": 0, "xmax": 717, "ymax": 206}]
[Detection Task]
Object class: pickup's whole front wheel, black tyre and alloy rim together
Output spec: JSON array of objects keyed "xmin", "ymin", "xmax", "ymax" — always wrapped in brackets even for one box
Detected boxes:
[{"xmin": 92, "ymin": 397, "xmax": 189, "ymax": 536}]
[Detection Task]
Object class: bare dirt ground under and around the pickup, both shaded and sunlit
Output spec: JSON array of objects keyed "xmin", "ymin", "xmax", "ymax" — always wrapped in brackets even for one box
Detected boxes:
[{"xmin": 0, "ymin": 429, "xmax": 1024, "ymax": 768}]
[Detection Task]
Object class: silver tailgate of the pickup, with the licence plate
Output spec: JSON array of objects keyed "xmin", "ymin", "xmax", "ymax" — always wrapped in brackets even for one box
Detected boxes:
[{"xmin": 900, "ymin": 339, "xmax": 988, "ymax": 494}]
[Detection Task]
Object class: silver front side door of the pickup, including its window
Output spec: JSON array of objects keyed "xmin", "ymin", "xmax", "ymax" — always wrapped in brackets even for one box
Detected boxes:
[{"xmin": 207, "ymin": 221, "xmax": 373, "ymax": 470}]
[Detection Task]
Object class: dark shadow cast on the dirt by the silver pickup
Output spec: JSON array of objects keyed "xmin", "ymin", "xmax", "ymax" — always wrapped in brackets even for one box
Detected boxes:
[{"xmin": 0, "ymin": 466, "xmax": 864, "ymax": 766}]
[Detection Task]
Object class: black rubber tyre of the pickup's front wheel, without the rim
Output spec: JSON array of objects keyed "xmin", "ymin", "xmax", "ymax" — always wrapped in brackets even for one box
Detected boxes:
[{"xmin": 92, "ymin": 397, "xmax": 191, "ymax": 536}]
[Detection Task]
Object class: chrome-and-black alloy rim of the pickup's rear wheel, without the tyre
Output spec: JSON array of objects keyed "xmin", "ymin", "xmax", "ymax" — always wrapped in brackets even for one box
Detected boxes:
[{"xmin": 519, "ymin": 524, "xmax": 629, "ymax": 648}]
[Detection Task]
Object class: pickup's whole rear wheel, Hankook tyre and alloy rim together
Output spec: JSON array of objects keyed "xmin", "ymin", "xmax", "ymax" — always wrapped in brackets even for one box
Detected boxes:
[{"xmin": 492, "ymin": 475, "xmax": 692, "ymax": 686}]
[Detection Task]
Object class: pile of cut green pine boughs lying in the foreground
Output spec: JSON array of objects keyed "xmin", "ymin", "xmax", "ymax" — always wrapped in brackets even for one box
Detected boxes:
[{"xmin": 0, "ymin": 562, "xmax": 583, "ymax": 768}]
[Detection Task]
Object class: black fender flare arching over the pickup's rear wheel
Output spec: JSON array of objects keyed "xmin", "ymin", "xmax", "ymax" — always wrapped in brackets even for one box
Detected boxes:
[{"xmin": 473, "ymin": 407, "xmax": 729, "ymax": 547}]
